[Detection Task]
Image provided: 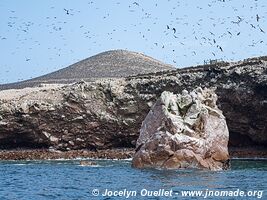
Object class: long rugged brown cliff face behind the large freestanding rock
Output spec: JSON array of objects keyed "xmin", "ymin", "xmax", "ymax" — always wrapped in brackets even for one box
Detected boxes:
[{"xmin": 0, "ymin": 57, "xmax": 267, "ymax": 150}]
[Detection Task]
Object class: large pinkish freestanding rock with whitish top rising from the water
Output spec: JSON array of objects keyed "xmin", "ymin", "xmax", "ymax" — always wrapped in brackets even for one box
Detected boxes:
[{"xmin": 132, "ymin": 88, "xmax": 229, "ymax": 170}]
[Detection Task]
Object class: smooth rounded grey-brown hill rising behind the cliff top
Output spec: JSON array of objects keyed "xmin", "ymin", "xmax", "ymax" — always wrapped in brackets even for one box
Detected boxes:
[{"xmin": 0, "ymin": 50, "xmax": 174, "ymax": 90}]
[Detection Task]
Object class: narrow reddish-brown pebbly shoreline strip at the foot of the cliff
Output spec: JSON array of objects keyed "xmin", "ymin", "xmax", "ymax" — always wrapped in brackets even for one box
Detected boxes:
[{"xmin": 0, "ymin": 147, "xmax": 267, "ymax": 160}]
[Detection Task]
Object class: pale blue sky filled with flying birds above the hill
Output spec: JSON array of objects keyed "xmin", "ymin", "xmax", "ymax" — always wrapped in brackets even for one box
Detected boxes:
[{"xmin": 0, "ymin": 0, "xmax": 267, "ymax": 84}]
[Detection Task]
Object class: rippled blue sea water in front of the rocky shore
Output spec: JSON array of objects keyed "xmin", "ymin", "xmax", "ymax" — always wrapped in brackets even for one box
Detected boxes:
[{"xmin": 0, "ymin": 160, "xmax": 267, "ymax": 200}]
